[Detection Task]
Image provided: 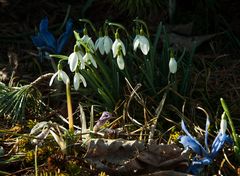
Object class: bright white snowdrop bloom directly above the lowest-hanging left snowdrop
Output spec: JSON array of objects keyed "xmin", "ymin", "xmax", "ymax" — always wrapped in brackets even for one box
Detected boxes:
[{"xmin": 68, "ymin": 52, "xmax": 85, "ymax": 72}]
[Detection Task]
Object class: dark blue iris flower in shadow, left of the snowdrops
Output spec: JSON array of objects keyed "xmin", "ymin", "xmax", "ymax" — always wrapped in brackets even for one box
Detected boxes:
[{"xmin": 32, "ymin": 17, "xmax": 73, "ymax": 54}]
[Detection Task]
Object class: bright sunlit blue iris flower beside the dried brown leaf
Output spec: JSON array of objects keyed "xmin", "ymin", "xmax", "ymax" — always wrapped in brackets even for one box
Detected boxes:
[{"xmin": 179, "ymin": 118, "xmax": 232, "ymax": 174}]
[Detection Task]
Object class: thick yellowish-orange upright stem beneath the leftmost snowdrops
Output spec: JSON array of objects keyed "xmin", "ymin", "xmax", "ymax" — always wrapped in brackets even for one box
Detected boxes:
[{"xmin": 66, "ymin": 81, "xmax": 74, "ymax": 132}]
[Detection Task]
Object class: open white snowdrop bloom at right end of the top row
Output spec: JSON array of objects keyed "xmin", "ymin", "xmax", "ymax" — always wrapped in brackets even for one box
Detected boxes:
[{"xmin": 133, "ymin": 34, "xmax": 150, "ymax": 55}]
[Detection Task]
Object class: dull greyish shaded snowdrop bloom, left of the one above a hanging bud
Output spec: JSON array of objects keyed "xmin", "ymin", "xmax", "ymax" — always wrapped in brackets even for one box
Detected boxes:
[{"xmin": 95, "ymin": 35, "xmax": 113, "ymax": 55}]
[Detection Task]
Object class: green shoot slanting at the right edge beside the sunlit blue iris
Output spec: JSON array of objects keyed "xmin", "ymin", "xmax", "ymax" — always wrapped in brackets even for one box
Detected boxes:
[{"xmin": 220, "ymin": 98, "xmax": 240, "ymax": 152}]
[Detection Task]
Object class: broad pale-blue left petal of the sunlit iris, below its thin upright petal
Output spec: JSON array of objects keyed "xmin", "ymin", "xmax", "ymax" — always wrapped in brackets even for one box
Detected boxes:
[{"xmin": 179, "ymin": 136, "xmax": 204, "ymax": 156}]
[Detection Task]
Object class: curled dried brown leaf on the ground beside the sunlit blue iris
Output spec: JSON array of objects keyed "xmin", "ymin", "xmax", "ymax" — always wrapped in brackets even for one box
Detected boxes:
[{"xmin": 85, "ymin": 139, "xmax": 189, "ymax": 173}]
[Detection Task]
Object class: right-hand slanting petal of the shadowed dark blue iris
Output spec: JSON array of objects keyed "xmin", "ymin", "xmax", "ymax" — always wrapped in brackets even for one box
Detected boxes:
[{"xmin": 56, "ymin": 19, "xmax": 73, "ymax": 54}]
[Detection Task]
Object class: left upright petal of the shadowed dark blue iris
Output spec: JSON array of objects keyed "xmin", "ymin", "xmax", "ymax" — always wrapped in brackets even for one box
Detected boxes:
[{"xmin": 39, "ymin": 17, "xmax": 56, "ymax": 50}]
